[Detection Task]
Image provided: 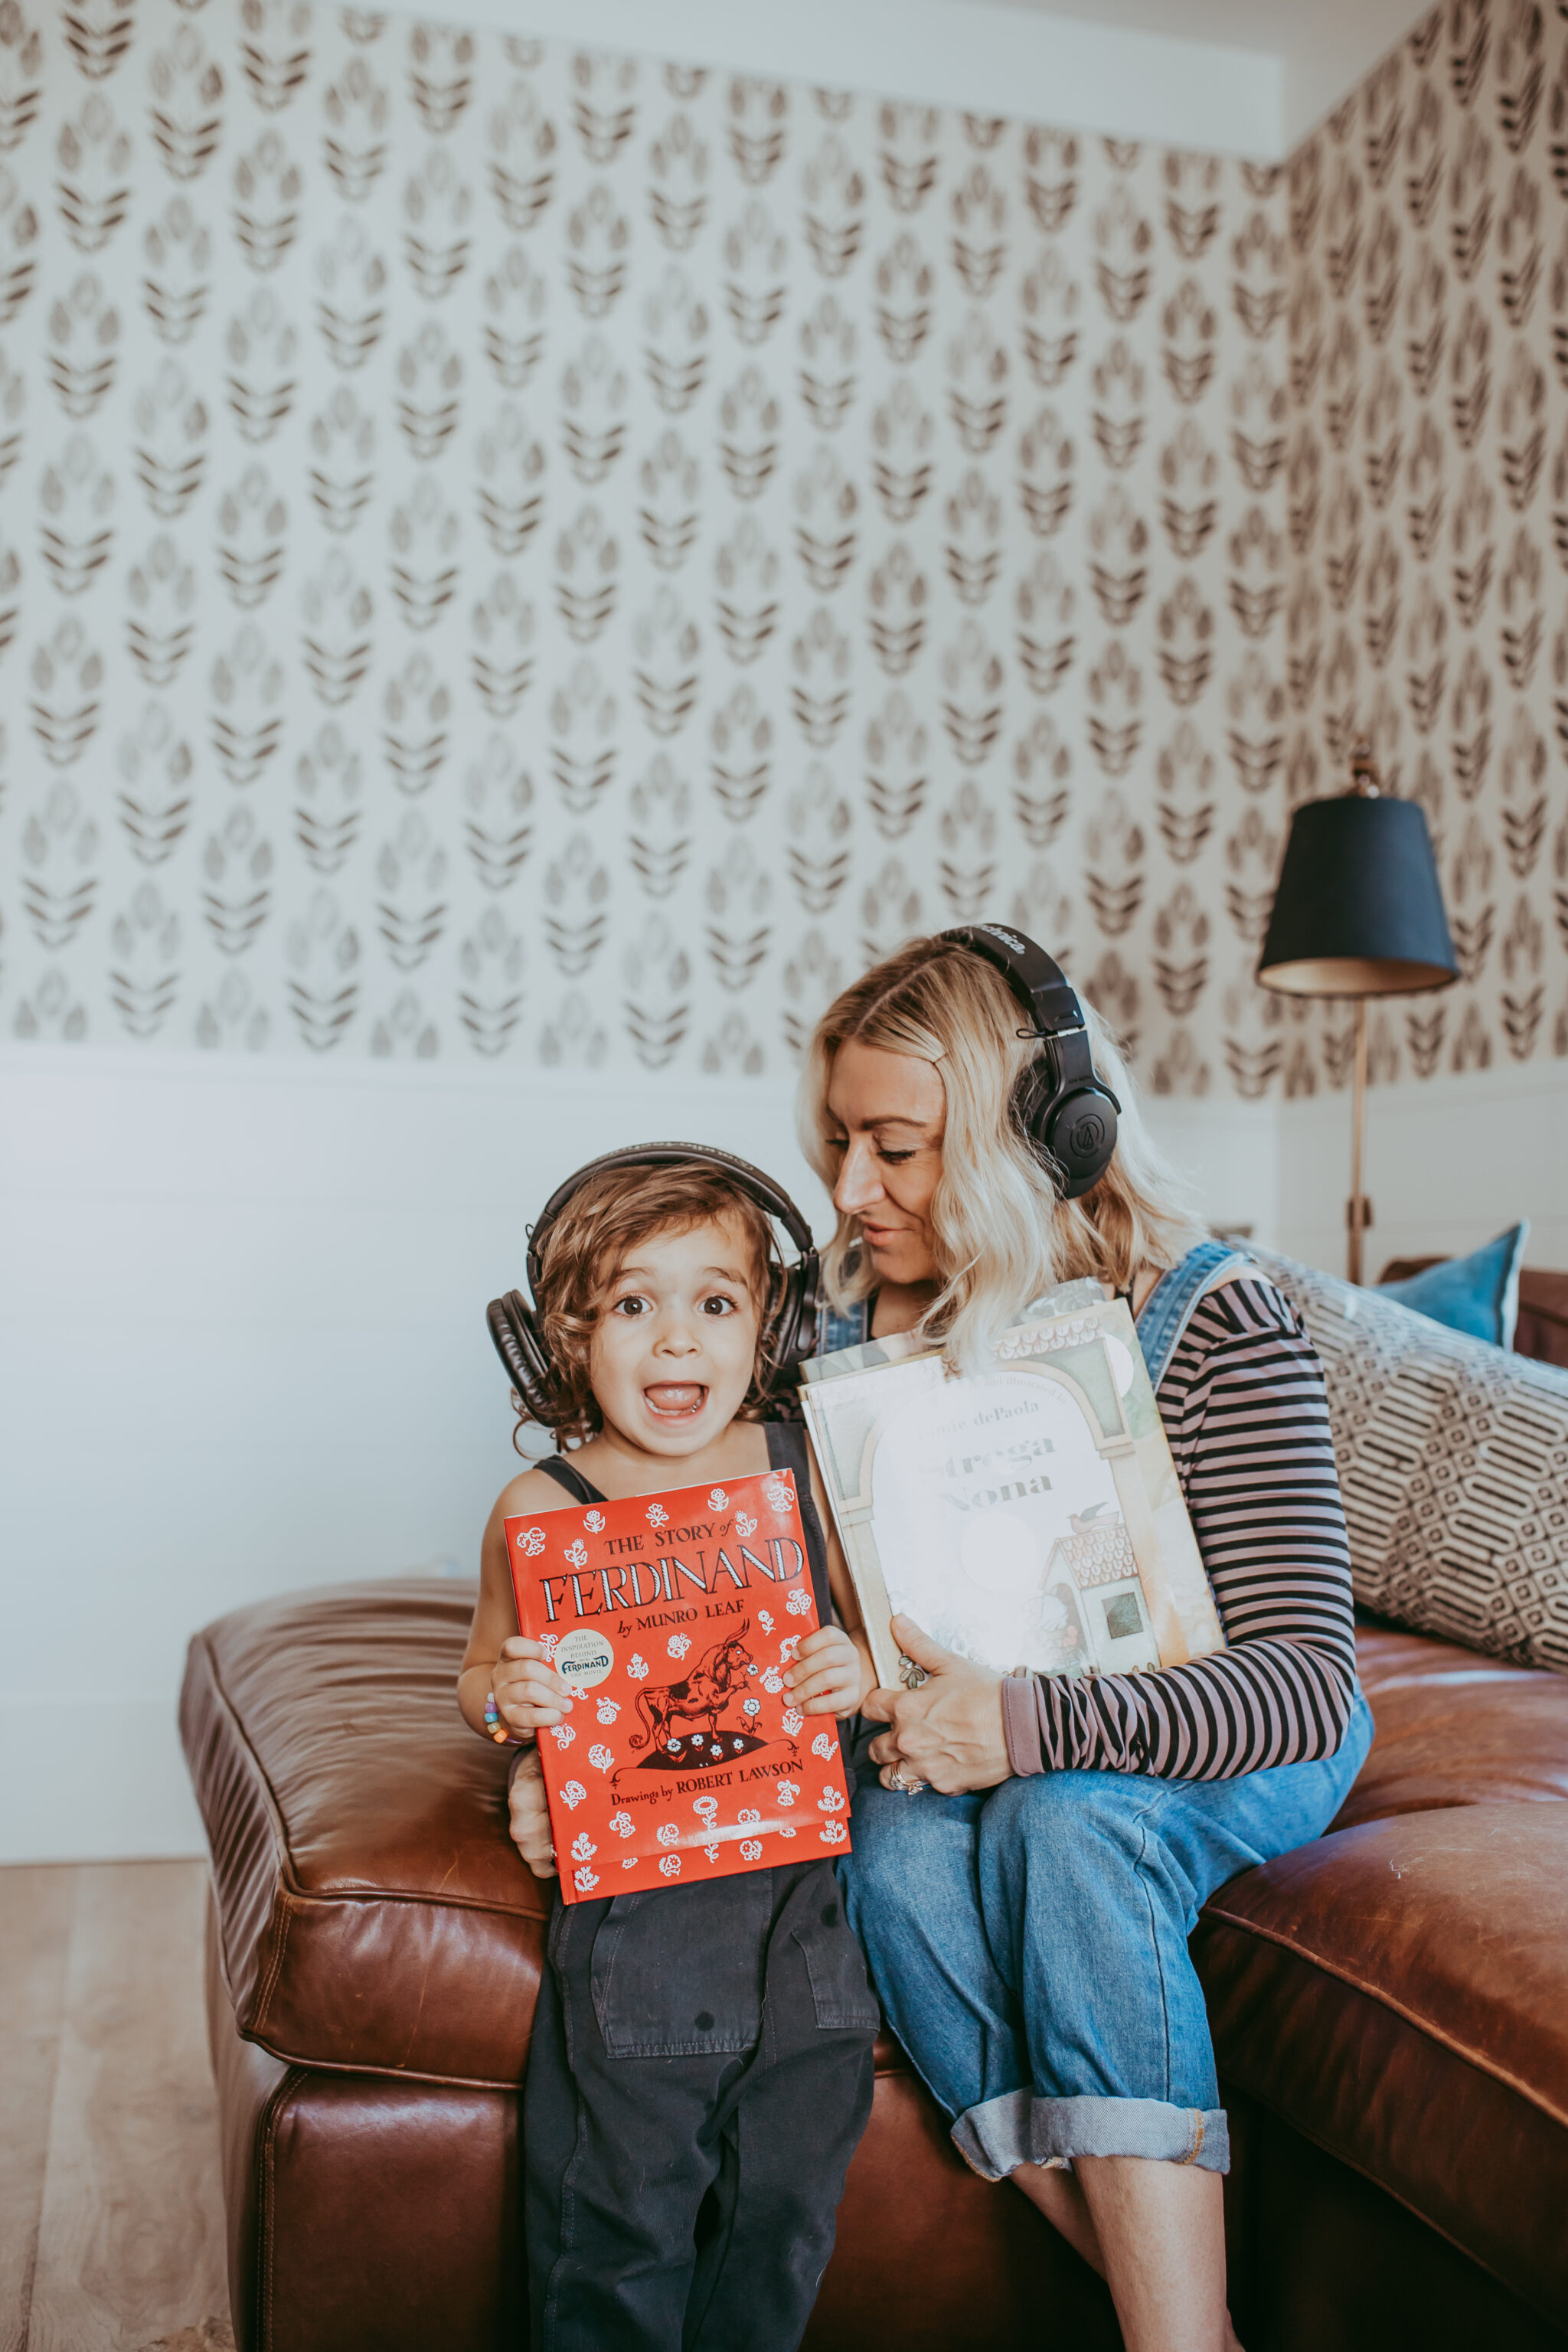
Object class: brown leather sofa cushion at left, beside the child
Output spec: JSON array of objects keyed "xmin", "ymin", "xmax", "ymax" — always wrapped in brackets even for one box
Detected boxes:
[{"xmin": 181, "ymin": 1578, "xmax": 550, "ymax": 2086}]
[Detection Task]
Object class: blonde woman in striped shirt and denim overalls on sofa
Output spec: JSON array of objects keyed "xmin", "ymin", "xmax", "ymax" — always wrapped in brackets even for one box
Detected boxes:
[{"xmin": 802, "ymin": 936, "xmax": 1370, "ymax": 2352}]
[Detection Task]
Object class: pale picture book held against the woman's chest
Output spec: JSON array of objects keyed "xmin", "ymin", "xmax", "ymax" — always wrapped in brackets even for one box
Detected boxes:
[{"xmin": 802, "ymin": 1284, "xmax": 1225, "ymax": 1689}]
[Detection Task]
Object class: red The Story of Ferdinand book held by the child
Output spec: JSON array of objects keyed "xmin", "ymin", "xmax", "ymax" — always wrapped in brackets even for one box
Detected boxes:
[{"xmin": 505, "ymin": 1470, "xmax": 848, "ymax": 1903}]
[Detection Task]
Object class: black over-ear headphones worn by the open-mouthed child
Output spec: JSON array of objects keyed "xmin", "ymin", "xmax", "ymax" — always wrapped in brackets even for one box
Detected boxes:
[{"xmin": 485, "ymin": 1143, "xmax": 821, "ymax": 1426}]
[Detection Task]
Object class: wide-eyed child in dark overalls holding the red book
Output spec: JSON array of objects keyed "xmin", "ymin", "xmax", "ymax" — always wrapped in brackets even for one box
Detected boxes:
[{"xmin": 459, "ymin": 1162, "xmax": 877, "ymax": 2352}]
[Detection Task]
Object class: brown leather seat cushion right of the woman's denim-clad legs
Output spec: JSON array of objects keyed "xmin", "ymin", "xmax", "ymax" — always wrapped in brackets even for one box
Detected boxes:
[{"xmin": 1192, "ymin": 1804, "xmax": 1568, "ymax": 2326}]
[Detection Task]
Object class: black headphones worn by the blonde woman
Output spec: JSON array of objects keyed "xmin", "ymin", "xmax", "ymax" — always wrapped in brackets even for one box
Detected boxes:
[{"xmin": 936, "ymin": 922, "xmax": 1122, "ymax": 1200}]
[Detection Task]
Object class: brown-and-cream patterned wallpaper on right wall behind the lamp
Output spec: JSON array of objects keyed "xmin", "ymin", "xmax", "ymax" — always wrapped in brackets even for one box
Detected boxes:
[{"xmin": 1283, "ymin": 0, "xmax": 1568, "ymax": 1093}]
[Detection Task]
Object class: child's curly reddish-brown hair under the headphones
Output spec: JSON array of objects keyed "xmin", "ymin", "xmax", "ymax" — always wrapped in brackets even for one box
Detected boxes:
[{"xmin": 512, "ymin": 1159, "xmax": 782, "ymax": 1453}]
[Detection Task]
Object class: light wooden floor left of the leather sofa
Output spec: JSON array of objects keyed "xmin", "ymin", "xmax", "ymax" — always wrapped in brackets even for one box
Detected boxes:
[{"xmin": 0, "ymin": 1863, "xmax": 233, "ymax": 2352}]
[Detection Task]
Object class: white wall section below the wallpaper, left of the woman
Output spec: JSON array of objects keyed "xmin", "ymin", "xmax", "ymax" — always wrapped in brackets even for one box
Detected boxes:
[{"xmin": 0, "ymin": 1047, "xmax": 823, "ymax": 1860}]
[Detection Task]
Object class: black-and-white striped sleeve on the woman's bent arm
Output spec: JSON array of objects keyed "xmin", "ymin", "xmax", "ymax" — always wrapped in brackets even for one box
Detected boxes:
[{"xmin": 1001, "ymin": 1275, "xmax": 1357, "ymax": 1781}]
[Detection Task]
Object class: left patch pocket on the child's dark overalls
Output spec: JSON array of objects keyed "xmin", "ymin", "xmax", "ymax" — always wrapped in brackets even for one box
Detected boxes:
[{"xmin": 590, "ymin": 1870, "xmax": 771, "ymax": 2058}]
